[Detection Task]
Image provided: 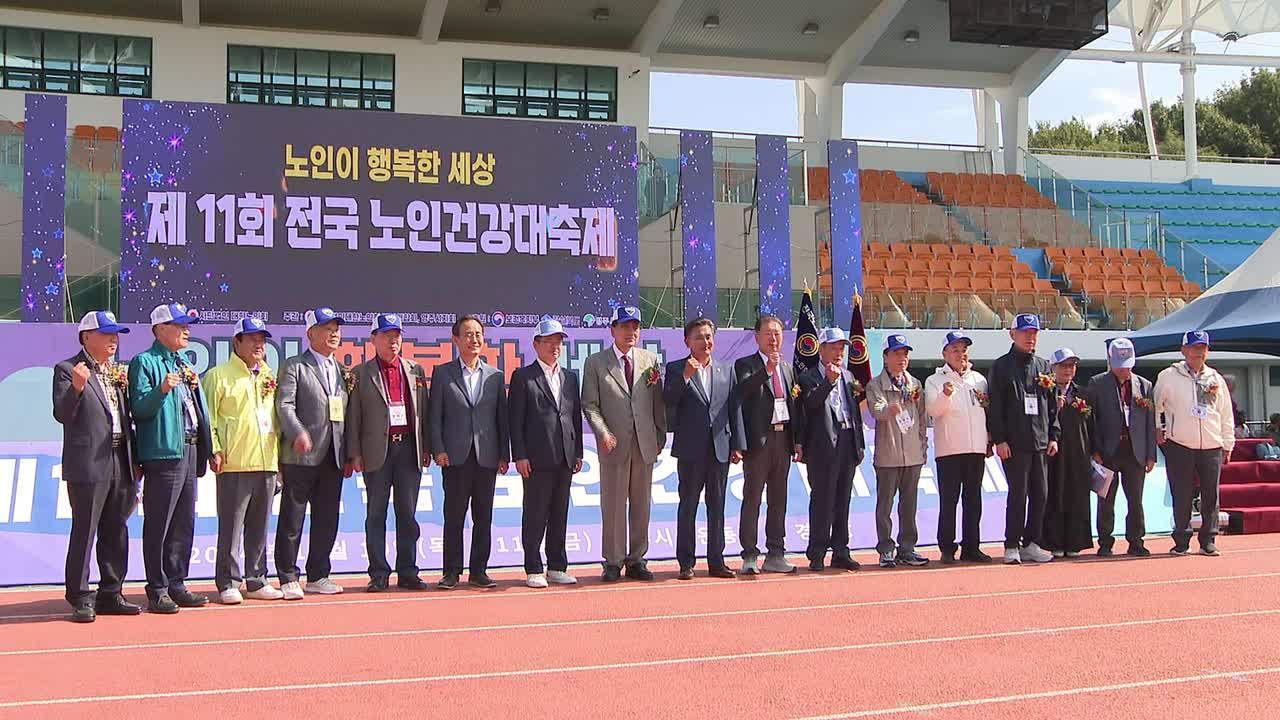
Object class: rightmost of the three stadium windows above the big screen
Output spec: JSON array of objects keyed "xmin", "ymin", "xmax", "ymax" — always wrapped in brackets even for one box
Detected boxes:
[{"xmin": 462, "ymin": 59, "xmax": 618, "ymax": 122}]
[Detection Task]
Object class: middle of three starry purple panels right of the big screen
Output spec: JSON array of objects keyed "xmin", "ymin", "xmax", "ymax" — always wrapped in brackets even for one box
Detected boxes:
[{"xmin": 755, "ymin": 135, "xmax": 791, "ymax": 328}]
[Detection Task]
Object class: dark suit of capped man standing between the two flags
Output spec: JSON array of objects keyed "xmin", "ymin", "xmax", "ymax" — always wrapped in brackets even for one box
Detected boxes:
[{"xmin": 797, "ymin": 368, "xmax": 867, "ymax": 561}]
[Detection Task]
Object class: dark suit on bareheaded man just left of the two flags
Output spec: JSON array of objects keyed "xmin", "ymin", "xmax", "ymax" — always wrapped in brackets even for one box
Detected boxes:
[{"xmin": 733, "ymin": 352, "xmax": 804, "ymax": 561}]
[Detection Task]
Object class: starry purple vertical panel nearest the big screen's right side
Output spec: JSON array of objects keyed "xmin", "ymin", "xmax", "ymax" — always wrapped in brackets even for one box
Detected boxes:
[{"xmin": 680, "ymin": 129, "xmax": 717, "ymax": 320}]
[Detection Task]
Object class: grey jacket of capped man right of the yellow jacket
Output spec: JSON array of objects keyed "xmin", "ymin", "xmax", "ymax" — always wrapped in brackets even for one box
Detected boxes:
[{"xmin": 275, "ymin": 350, "xmax": 349, "ymax": 468}]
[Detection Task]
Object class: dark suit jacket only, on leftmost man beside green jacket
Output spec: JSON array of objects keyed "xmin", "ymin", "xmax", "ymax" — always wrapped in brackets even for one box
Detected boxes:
[{"xmin": 54, "ymin": 351, "xmax": 137, "ymax": 484}]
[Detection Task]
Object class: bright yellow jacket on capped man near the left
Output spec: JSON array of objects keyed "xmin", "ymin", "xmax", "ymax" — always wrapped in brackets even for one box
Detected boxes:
[{"xmin": 201, "ymin": 354, "xmax": 280, "ymax": 473}]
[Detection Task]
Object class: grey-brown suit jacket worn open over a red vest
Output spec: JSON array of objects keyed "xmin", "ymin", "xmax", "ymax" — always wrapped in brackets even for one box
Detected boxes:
[{"xmin": 347, "ymin": 357, "xmax": 431, "ymax": 473}]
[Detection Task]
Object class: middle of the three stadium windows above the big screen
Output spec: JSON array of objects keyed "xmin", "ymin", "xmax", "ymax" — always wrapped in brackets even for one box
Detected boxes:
[{"xmin": 227, "ymin": 45, "xmax": 396, "ymax": 110}]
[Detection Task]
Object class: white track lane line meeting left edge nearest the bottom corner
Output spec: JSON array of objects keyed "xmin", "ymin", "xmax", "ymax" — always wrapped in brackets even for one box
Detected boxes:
[{"xmin": 0, "ymin": 609, "xmax": 1280, "ymax": 710}]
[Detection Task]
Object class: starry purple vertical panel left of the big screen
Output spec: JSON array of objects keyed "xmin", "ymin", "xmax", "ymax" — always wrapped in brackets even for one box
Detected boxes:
[{"xmin": 22, "ymin": 95, "xmax": 67, "ymax": 323}]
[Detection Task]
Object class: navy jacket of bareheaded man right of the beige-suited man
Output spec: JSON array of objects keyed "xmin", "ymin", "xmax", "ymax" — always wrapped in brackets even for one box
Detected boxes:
[{"xmin": 662, "ymin": 357, "xmax": 745, "ymax": 462}]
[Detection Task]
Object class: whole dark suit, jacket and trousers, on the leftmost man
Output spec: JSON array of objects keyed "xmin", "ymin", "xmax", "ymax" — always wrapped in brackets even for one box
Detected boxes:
[{"xmin": 54, "ymin": 351, "xmax": 138, "ymax": 607}]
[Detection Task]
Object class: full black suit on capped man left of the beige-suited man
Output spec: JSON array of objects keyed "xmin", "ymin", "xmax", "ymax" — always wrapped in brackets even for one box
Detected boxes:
[{"xmin": 507, "ymin": 361, "xmax": 582, "ymax": 574}]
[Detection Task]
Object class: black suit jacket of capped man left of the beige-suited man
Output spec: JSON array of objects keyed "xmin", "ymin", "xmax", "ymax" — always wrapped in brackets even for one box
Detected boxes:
[{"xmin": 507, "ymin": 361, "xmax": 582, "ymax": 470}]
